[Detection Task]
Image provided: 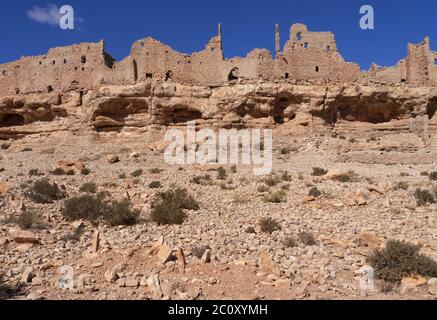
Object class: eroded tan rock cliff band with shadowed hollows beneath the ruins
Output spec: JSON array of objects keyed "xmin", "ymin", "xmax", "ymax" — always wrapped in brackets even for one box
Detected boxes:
[{"xmin": 0, "ymin": 82, "xmax": 437, "ymax": 138}]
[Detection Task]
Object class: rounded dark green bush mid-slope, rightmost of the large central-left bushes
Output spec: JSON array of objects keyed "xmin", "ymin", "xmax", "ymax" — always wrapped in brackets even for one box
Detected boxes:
[{"xmin": 151, "ymin": 188, "xmax": 199, "ymax": 225}]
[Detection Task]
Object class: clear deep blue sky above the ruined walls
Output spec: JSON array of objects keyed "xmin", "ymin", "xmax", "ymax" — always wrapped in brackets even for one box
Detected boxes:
[{"xmin": 0, "ymin": 0, "xmax": 437, "ymax": 69}]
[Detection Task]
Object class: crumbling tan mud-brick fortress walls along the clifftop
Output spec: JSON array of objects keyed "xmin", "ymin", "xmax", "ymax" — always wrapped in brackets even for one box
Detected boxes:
[{"xmin": 0, "ymin": 24, "xmax": 437, "ymax": 96}]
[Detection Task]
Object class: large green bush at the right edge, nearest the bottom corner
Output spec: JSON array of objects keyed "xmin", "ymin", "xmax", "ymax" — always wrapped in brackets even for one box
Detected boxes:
[{"xmin": 367, "ymin": 241, "xmax": 437, "ymax": 283}]
